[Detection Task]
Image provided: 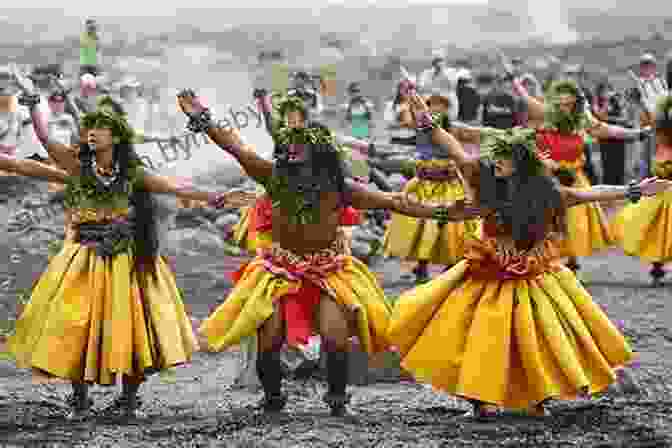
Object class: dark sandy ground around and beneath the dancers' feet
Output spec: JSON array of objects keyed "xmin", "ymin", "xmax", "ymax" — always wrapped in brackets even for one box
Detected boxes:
[{"xmin": 0, "ymin": 242, "xmax": 672, "ymax": 448}]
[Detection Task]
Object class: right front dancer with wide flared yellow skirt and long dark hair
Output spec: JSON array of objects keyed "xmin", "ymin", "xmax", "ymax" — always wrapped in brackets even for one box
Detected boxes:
[{"xmin": 388, "ymin": 92, "xmax": 672, "ymax": 418}]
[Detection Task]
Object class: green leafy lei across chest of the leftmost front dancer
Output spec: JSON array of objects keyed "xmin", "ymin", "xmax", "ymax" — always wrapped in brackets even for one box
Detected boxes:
[{"xmin": 64, "ymin": 160, "xmax": 143, "ymax": 208}]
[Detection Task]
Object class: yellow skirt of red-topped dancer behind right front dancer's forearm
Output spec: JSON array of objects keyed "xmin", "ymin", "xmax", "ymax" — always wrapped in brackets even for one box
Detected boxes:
[{"xmin": 562, "ymin": 170, "xmax": 614, "ymax": 257}]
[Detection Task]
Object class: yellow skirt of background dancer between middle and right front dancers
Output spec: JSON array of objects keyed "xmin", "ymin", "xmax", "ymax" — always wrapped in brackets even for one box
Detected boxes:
[{"xmin": 384, "ymin": 178, "xmax": 480, "ymax": 266}]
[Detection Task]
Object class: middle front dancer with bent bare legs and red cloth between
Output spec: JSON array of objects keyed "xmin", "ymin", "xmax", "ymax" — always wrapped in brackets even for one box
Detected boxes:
[{"xmin": 179, "ymin": 91, "xmax": 472, "ymax": 416}]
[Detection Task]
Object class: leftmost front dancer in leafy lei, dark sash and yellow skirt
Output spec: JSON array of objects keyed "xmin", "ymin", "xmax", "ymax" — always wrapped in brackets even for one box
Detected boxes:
[{"xmin": 8, "ymin": 75, "xmax": 253, "ymax": 418}]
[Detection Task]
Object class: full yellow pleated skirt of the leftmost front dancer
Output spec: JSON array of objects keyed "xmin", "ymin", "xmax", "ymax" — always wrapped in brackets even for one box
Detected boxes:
[{"xmin": 8, "ymin": 241, "xmax": 198, "ymax": 385}]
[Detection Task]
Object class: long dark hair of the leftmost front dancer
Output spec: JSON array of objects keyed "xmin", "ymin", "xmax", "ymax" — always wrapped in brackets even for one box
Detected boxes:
[{"xmin": 79, "ymin": 143, "xmax": 159, "ymax": 275}]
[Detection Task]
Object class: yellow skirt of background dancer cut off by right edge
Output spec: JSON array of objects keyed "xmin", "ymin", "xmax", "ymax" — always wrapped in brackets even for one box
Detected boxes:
[{"xmin": 611, "ymin": 191, "xmax": 672, "ymax": 263}]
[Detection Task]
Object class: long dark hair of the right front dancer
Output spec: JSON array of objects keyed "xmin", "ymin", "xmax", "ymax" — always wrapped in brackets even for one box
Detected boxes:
[{"xmin": 479, "ymin": 149, "xmax": 566, "ymax": 245}]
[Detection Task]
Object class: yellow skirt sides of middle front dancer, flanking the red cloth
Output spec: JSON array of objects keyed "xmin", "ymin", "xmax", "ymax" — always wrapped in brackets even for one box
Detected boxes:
[{"xmin": 199, "ymin": 256, "xmax": 391, "ymax": 353}]
